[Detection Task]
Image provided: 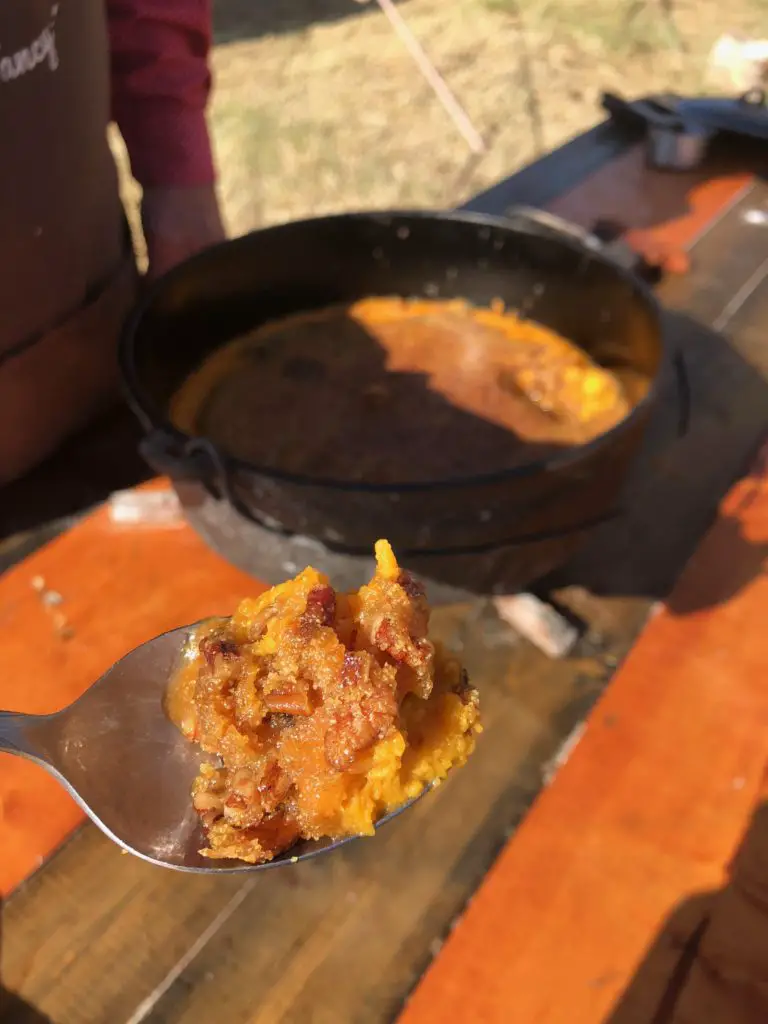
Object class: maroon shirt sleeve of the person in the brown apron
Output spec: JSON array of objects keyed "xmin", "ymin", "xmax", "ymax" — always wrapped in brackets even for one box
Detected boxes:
[{"xmin": 106, "ymin": 0, "xmax": 214, "ymax": 185}]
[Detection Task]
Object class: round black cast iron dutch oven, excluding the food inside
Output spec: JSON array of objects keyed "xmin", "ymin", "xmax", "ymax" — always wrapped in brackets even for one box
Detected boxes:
[{"xmin": 121, "ymin": 209, "xmax": 669, "ymax": 593}]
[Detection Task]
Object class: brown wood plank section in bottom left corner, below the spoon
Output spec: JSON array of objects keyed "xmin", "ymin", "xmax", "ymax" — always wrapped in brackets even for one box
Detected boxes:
[{"xmin": 0, "ymin": 825, "xmax": 244, "ymax": 1024}]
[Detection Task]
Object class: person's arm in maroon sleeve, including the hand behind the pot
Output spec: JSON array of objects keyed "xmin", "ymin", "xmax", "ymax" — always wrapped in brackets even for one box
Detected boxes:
[{"xmin": 106, "ymin": 0, "xmax": 223, "ymax": 275}]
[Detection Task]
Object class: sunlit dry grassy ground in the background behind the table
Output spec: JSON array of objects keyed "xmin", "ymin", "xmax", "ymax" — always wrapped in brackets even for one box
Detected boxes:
[{"xmin": 117, "ymin": 0, "xmax": 768, "ymax": 243}]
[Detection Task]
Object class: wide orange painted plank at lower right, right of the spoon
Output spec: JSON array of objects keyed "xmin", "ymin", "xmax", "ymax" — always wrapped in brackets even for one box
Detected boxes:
[{"xmin": 399, "ymin": 449, "xmax": 768, "ymax": 1024}]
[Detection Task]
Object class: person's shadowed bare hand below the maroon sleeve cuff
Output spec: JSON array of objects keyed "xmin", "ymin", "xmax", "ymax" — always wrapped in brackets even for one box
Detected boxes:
[{"xmin": 141, "ymin": 185, "xmax": 225, "ymax": 281}]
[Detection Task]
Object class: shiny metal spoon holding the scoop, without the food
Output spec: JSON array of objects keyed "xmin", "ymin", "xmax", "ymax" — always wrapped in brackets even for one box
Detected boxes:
[{"xmin": 0, "ymin": 626, "xmax": 419, "ymax": 872}]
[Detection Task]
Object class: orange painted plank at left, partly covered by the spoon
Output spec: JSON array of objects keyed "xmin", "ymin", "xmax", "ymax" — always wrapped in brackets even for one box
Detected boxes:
[{"xmin": 0, "ymin": 481, "xmax": 264, "ymax": 894}]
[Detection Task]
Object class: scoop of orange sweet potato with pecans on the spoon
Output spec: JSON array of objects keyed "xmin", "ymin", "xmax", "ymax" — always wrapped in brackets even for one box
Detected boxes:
[{"xmin": 168, "ymin": 541, "xmax": 480, "ymax": 863}]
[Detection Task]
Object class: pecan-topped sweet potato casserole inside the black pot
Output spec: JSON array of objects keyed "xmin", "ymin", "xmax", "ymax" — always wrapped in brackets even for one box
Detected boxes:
[{"xmin": 171, "ymin": 297, "xmax": 634, "ymax": 483}]
